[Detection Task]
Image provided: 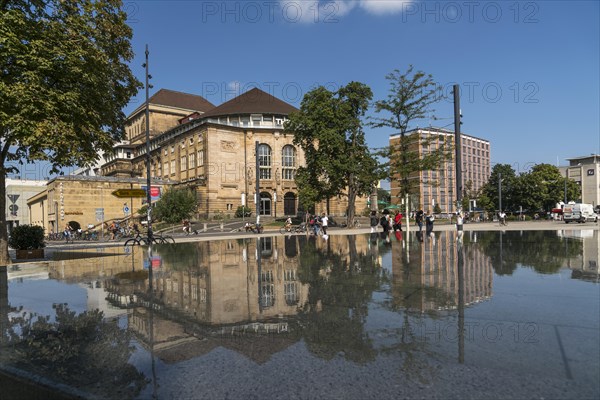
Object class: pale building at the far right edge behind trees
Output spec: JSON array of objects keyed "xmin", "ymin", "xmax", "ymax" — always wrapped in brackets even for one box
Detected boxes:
[{"xmin": 559, "ymin": 154, "xmax": 600, "ymax": 206}]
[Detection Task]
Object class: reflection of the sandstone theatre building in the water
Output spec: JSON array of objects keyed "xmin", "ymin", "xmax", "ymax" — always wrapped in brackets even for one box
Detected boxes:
[{"xmin": 43, "ymin": 235, "xmax": 376, "ymax": 363}]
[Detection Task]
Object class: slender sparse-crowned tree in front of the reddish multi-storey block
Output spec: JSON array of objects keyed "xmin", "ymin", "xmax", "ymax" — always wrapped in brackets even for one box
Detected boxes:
[{"xmin": 371, "ymin": 65, "xmax": 452, "ymax": 206}]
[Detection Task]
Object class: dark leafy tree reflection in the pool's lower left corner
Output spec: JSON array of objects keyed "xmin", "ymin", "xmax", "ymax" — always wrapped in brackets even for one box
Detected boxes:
[{"xmin": 0, "ymin": 304, "xmax": 147, "ymax": 398}]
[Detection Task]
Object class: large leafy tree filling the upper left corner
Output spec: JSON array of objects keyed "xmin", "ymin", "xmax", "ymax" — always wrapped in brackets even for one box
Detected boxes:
[{"xmin": 0, "ymin": 0, "xmax": 140, "ymax": 265}]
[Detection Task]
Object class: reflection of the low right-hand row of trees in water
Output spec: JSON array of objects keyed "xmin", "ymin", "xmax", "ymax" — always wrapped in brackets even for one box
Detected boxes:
[{"xmin": 477, "ymin": 231, "xmax": 583, "ymax": 275}]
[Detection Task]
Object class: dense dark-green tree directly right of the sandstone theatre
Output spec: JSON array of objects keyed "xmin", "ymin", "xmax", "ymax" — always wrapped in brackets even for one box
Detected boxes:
[{"xmin": 286, "ymin": 82, "xmax": 378, "ymax": 226}]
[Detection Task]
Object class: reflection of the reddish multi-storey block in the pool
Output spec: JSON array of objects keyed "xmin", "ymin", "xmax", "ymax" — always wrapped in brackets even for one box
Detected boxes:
[{"xmin": 392, "ymin": 232, "xmax": 494, "ymax": 311}]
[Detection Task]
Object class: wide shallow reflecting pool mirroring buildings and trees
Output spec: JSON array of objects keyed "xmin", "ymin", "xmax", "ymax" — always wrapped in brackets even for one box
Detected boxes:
[{"xmin": 0, "ymin": 230, "xmax": 600, "ymax": 399}]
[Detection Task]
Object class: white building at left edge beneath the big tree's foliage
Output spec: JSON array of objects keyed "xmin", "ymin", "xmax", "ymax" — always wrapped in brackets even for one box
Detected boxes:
[{"xmin": 5, "ymin": 178, "xmax": 46, "ymax": 234}]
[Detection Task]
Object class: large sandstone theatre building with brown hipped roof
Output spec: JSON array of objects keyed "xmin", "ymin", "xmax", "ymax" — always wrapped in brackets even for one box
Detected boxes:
[{"xmin": 100, "ymin": 88, "xmax": 366, "ymax": 218}]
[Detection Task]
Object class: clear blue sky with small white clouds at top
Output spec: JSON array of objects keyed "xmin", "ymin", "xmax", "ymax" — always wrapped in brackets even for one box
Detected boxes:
[{"xmin": 14, "ymin": 0, "xmax": 600, "ymax": 179}]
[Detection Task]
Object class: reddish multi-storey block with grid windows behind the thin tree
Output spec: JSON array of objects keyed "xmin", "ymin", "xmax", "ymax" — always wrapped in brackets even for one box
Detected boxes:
[{"xmin": 390, "ymin": 128, "xmax": 491, "ymax": 213}]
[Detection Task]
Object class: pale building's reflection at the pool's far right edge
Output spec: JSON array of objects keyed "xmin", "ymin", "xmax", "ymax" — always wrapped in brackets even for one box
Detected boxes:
[{"xmin": 557, "ymin": 229, "xmax": 600, "ymax": 282}]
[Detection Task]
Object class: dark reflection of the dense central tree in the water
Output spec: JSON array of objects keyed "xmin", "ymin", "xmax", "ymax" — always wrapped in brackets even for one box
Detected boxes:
[{"xmin": 298, "ymin": 235, "xmax": 380, "ymax": 363}]
